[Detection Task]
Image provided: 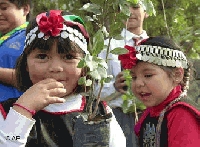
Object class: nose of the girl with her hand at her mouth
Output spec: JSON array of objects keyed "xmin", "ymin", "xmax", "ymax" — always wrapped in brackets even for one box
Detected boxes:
[{"xmin": 49, "ymin": 59, "xmax": 63, "ymax": 72}]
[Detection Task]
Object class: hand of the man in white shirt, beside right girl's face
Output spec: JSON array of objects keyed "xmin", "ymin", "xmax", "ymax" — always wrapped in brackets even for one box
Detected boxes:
[{"xmin": 114, "ymin": 71, "xmax": 127, "ymax": 94}]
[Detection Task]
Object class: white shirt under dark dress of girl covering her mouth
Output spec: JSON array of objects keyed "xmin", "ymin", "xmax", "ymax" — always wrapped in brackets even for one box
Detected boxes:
[{"xmin": 0, "ymin": 95, "xmax": 126, "ymax": 147}]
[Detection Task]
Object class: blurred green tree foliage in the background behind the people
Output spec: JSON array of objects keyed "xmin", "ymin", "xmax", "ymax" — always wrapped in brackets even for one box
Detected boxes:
[{"xmin": 32, "ymin": 0, "xmax": 200, "ymax": 59}]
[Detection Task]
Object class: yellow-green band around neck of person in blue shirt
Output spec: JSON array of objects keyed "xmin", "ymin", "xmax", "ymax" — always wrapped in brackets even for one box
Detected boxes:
[{"xmin": 0, "ymin": 22, "xmax": 28, "ymax": 45}]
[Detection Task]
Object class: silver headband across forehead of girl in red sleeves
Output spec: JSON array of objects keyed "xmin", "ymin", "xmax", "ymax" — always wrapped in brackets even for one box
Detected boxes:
[{"xmin": 135, "ymin": 45, "xmax": 188, "ymax": 69}]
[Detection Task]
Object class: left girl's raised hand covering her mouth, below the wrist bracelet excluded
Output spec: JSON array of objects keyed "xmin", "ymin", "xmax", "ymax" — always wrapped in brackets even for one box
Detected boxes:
[{"xmin": 16, "ymin": 79, "xmax": 66, "ymax": 111}]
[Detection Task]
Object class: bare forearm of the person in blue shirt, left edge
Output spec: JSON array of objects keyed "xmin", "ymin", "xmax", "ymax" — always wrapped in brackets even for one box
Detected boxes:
[{"xmin": 0, "ymin": 68, "xmax": 16, "ymax": 86}]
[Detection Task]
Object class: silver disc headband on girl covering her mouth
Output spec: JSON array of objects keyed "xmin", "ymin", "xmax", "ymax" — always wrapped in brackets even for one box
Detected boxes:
[{"xmin": 24, "ymin": 24, "xmax": 89, "ymax": 54}]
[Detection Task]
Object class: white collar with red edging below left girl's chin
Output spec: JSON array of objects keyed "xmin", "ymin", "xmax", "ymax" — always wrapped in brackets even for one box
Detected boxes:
[{"xmin": 43, "ymin": 94, "xmax": 86, "ymax": 115}]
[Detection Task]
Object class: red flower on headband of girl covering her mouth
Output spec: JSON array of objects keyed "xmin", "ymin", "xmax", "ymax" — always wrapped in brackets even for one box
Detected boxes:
[{"xmin": 36, "ymin": 10, "xmax": 64, "ymax": 36}]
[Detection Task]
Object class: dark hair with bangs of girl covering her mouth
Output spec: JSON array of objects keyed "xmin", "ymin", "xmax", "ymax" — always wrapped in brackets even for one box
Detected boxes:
[{"xmin": 15, "ymin": 11, "xmax": 90, "ymax": 93}]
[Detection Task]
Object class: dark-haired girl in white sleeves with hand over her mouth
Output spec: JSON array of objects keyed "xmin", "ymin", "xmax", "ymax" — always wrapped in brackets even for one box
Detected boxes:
[{"xmin": 0, "ymin": 10, "xmax": 126, "ymax": 147}]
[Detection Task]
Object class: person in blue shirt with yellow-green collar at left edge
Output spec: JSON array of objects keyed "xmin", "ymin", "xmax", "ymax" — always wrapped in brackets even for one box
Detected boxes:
[{"xmin": 0, "ymin": 0, "xmax": 30, "ymax": 101}]
